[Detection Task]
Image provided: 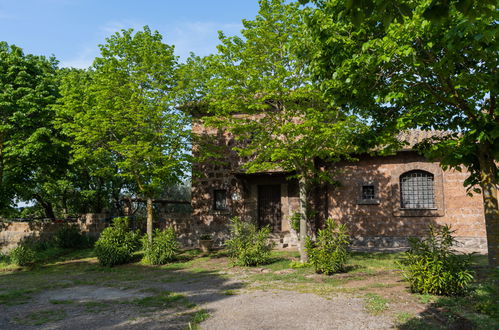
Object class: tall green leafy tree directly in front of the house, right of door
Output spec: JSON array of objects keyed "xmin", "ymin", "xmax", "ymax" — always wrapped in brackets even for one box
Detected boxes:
[{"xmin": 201, "ymin": 0, "xmax": 361, "ymax": 261}]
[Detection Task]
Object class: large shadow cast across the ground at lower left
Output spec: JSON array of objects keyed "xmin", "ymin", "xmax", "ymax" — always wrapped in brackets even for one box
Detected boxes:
[{"xmin": 0, "ymin": 251, "xmax": 243, "ymax": 329}]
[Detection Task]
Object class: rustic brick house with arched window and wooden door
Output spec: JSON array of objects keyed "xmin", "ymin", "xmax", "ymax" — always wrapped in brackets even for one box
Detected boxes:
[{"xmin": 191, "ymin": 122, "xmax": 487, "ymax": 252}]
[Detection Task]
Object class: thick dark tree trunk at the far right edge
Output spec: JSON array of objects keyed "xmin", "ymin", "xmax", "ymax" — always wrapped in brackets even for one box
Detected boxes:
[{"xmin": 478, "ymin": 143, "xmax": 499, "ymax": 268}]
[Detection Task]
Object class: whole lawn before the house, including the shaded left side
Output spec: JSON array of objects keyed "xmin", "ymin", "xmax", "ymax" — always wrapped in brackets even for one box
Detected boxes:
[{"xmin": 0, "ymin": 249, "xmax": 499, "ymax": 329}]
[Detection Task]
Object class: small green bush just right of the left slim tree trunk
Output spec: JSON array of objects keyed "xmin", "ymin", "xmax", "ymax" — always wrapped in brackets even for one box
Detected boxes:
[{"xmin": 142, "ymin": 227, "xmax": 179, "ymax": 265}]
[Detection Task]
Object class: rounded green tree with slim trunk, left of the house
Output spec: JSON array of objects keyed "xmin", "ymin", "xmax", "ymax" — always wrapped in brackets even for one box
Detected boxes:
[{"xmin": 57, "ymin": 26, "xmax": 189, "ymax": 239}]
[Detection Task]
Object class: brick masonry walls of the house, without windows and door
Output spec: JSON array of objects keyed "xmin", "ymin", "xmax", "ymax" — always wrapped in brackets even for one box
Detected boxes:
[{"xmin": 190, "ymin": 122, "xmax": 486, "ymax": 252}]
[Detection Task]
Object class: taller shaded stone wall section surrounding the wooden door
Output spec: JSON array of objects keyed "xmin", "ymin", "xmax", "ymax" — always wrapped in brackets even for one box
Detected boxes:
[{"xmin": 188, "ymin": 122, "xmax": 298, "ymax": 246}]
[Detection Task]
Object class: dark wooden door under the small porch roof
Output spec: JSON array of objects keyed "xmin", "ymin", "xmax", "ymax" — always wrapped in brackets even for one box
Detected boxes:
[{"xmin": 258, "ymin": 184, "xmax": 282, "ymax": 233}]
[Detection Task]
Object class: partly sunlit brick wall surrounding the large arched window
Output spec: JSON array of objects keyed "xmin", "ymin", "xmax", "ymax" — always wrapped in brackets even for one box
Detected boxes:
[{"xmin": 327, "ymin": 152, "xmax": 486, "ymax": 251}]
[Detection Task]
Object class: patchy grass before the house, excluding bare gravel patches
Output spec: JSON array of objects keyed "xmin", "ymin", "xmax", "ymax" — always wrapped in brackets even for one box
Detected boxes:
[{"xmin": 0, "ymin": 249, "xmax": 499, "ymax": 329}]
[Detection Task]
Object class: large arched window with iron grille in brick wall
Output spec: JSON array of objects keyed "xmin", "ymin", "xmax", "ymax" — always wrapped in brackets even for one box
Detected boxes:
[{"xmin": 400, "ymin": 170, "xmax": 435, "ymax": 209}]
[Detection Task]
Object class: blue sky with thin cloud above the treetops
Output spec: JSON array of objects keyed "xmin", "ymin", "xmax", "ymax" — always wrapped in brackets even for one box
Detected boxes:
[{"xmin": 0, "ymin": 0, "xmax": 258, "ymax": 68}]
